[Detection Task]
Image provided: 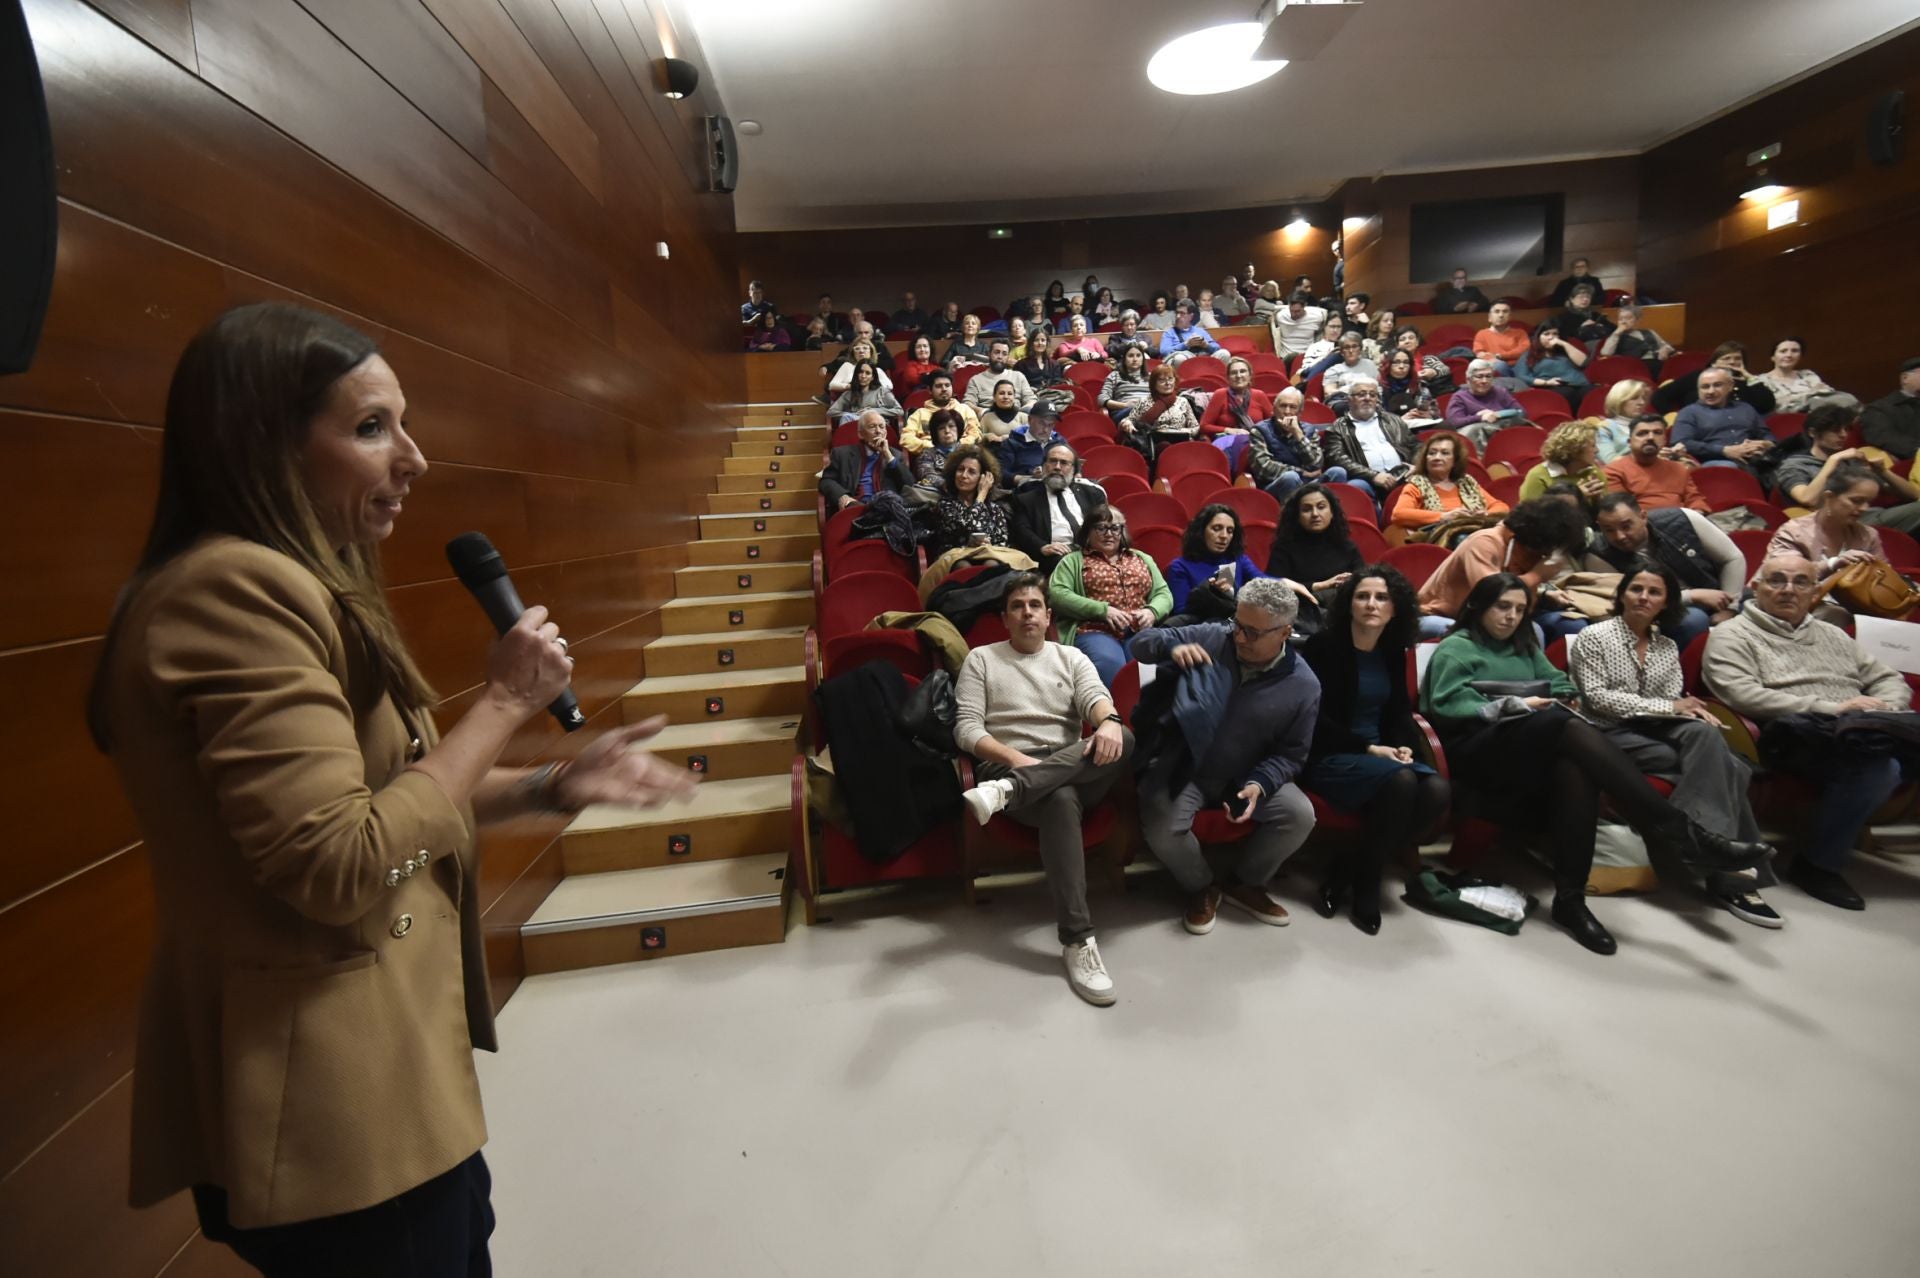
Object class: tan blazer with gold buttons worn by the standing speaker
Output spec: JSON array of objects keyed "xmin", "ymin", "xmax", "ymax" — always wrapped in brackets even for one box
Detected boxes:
[{"xmin": 108, "ymin": 537, "xmax": 495, "ymax": 1228}]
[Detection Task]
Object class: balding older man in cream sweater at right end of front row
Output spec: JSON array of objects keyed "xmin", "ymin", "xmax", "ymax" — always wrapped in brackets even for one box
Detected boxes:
[{"xmin": 1701, "ymin": 555, "xmax": 1920, "ymax": 910}]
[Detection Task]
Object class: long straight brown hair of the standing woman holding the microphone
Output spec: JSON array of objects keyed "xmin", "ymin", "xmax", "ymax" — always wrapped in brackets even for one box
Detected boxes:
[{"xmin": 86, "ymin": 301, "xmax": 434, "ymax": 750}]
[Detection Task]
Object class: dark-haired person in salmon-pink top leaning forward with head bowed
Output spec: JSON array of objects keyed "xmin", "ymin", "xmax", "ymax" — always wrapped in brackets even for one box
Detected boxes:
[{"xmin": 1421, "ymin": 497, "xmax": 1588, "ymax": 639}]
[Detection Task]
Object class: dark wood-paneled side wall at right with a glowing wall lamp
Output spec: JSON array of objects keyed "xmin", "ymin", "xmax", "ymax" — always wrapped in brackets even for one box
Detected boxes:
[{"xmin": 1640, "ymin": 31, "xmax": 1920, "ymax": 401}]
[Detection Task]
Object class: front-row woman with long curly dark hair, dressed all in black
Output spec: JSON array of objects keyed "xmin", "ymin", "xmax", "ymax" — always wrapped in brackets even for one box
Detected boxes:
[{"xmin": 1300, "ymin": 564, "xmax": 1448, "ymax": 936}]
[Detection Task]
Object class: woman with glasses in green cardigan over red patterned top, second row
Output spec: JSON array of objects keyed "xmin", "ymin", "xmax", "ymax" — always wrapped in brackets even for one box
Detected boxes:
[{"xmin": 1046, "ymin": 507, "xmax": 1173, "ymax": 687}]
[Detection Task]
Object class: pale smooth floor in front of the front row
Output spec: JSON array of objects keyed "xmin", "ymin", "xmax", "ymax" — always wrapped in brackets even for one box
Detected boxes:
[{"xmin": 480, "ymin": 854, "xmax": 1920, "ymax": 1278}]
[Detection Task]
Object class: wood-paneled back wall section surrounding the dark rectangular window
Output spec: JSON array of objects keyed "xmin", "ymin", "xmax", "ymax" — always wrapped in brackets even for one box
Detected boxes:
[{"xmin": 1340, "ymin": 155, "xmax": 1640, "ymax": 305}]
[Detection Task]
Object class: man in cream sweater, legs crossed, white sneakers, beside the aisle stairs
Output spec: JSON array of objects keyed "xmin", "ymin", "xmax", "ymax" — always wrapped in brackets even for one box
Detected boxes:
[{"xmin": 954, "ymin": 572, "xmax": 1133, "ymax": 1007}]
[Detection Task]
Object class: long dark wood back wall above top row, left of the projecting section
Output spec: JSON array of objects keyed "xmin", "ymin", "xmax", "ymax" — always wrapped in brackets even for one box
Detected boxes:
[{"xmin": 739, "ymin": 205, "xmax": 1336, "ymax": 315}]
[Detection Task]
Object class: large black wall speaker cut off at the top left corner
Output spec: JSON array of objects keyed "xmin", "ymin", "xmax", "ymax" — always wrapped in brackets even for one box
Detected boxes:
[{"xmin": 0, "ymin": 0, "xmax": 60, "ymax": 372}]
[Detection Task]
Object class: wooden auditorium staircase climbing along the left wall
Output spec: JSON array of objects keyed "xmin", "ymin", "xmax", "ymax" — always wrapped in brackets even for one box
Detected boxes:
[{"xmin": 520, "ymin": 403, "xmax": 828, "ymax": 975}]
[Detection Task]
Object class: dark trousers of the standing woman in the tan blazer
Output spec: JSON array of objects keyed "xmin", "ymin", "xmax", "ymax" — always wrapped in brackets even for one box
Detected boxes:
[{"xmin": 194, "ymin": 1153, "xmax": 493, "ymax": 1278}]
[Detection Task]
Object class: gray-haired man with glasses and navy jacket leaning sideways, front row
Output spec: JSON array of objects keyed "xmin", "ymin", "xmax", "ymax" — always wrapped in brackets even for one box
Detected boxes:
[{"xmin": 1133, "ymin": 578, "xmax": 1319, "ymax": 936}]
